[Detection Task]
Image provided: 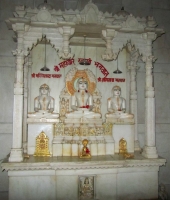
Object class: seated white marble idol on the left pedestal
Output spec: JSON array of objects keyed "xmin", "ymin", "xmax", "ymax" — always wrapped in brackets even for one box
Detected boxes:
[{"xmin": 28, "ymin": 84, "xmax": 59, "ymax": 119}]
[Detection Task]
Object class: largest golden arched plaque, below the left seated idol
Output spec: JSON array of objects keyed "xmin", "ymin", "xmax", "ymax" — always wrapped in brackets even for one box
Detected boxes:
[{"xmin": 34, "ymin": 131, "xmax": 51, "ymax": 156}]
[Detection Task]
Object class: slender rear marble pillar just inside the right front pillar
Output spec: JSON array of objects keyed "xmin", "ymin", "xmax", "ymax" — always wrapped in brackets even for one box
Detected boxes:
[{"xmin": 127, "ymin": 61, "xmax": 141, "ymax": 151}]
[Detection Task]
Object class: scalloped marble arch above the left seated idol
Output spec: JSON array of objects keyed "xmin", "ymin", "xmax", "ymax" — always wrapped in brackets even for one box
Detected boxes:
[{"xmin": 24, "ymin": 27, "xmax": 63, "ymax": 56}]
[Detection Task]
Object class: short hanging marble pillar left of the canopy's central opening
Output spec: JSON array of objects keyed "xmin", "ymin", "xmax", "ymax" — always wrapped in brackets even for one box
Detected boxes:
[{"xmin": 58, "ymin": 26, "xmax": 75, "ymax": 59}]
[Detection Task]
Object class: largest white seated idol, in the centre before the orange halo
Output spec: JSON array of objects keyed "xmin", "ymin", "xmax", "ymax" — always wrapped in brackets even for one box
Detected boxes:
[{"xmin": 66, "ymin": 77, "xmax": 101, "ymax": 118}]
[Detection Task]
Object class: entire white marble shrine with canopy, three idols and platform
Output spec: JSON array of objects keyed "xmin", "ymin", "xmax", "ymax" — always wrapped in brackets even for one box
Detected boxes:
[{"xmin": 1, "ymin": 1, "xmax": 167, "ymax": 200}]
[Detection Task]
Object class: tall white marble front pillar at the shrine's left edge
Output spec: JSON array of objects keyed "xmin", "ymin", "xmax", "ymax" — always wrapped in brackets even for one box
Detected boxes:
[{"xmin": 9, "ymin": 23, "xmax": 25, "ymax": 162}]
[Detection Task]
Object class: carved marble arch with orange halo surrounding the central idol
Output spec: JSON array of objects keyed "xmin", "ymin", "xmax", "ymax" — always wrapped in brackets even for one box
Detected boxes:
[{"xmin": 60, "ymin": 67, "xmax": 102, "ymax": 118}]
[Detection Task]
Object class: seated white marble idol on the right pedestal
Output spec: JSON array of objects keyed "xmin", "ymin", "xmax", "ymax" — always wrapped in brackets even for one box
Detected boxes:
[{"xmin": 106, "ymin": 86, "xmax": 134, "ymax": 119}]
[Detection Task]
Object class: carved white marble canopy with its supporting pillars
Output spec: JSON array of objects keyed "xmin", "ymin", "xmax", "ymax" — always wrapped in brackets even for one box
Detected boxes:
[{"xmin": 6, "ymin": 1, "xmax": 164, "ymax": 162}]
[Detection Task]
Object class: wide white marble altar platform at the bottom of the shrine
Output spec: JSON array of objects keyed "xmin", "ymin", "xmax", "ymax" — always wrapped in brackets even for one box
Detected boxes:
[{"xmin": 2, "ymin": 152, "xmax": 165, "ymax": 200}]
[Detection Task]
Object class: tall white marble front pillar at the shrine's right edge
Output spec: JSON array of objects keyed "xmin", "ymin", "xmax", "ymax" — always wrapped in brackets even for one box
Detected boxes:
[{"xmin": 142, "ymin": 32, "xmax": 158, "ymax": 158}]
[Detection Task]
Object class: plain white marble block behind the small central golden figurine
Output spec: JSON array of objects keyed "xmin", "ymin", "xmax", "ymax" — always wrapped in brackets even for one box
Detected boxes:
[{"xmin": 52, "ymin": 135, "xmax": 115, "ymax": 156}]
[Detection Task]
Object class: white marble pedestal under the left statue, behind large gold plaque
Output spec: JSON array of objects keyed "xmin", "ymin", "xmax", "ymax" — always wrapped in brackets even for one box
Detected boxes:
[{"xmin": 27, "ymin": 118, "xmax": 59, "ymax": 155}]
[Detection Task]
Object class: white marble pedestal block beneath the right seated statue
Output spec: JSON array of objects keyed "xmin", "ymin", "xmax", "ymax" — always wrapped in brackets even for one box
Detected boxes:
[{"xmin": 112, "ymin": 124, "xmax": 135, "ymax": 153}]
